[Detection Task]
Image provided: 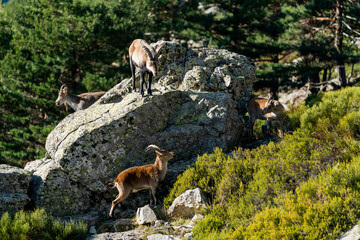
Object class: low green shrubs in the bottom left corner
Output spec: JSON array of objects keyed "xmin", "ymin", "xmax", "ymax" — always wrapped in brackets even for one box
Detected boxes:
[{"xmin": 0, "ymin": 209, "xmax": 87, "ymax": 240}]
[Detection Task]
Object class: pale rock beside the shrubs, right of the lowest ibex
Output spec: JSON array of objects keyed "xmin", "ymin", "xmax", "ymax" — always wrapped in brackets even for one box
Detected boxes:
[{"xmin": 168, "ymin": 188, "xmax": 206, "ymax": 218}]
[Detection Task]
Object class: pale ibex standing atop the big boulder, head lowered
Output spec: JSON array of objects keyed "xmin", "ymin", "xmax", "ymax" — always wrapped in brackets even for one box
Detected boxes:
[{"xmin": 129, "ymin": 39, "xmax": 157, "ymax": 96}]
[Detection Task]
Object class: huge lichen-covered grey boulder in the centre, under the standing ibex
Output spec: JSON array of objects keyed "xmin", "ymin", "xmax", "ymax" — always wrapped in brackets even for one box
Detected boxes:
[{"xmin": 26, "ymin": 41, "xmax": 255, "ymax": 216}]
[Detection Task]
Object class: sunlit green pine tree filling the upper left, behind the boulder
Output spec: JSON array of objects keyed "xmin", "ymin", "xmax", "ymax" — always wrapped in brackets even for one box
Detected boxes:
[{"xmin": 0, "ymin": 0, "xmax": 146, "ymax": 165}]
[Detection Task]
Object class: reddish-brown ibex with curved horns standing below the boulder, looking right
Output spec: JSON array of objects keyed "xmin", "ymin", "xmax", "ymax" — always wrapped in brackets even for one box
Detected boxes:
[{"xmin": 106, "ymin": 145, "xmax": 175, "ymax": 217}]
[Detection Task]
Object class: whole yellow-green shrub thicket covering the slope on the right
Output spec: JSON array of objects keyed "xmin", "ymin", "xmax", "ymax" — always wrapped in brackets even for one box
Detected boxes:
[{"xmin": 165, "ymin": 87, "xmax": 360, "ymax": 239}]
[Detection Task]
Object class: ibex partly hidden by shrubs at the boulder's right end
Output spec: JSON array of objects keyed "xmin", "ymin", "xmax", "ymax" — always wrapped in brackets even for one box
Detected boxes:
[{"xmin": 246, "ymin": 98, "xmax": 285, "ymax": 137}]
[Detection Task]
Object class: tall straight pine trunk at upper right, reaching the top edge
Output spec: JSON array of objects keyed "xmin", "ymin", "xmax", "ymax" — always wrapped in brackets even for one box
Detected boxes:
[{"xmin": 335, "ymin": 0, "xmax": 346, "ymax": 87}]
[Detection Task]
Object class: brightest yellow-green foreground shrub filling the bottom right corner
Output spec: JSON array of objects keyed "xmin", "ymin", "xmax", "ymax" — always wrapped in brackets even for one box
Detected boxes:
[{"xmin": 242, "ymin": 157, "xmax": 360, "ymax": 239}]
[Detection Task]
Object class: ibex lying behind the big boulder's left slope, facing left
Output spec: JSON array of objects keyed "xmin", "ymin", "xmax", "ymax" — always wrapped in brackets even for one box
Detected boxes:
[{"xmin": 55, "ymin": 84, "xmax": 105, "ymax": 111}]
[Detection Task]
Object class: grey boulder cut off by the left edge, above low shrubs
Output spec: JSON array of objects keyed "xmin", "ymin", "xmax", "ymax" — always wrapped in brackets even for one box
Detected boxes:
[{"xmin": 0, "ymin": 164, "xmax": 31, "ymax": 217}]
